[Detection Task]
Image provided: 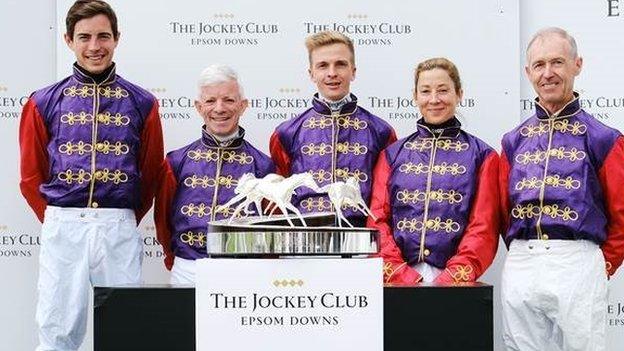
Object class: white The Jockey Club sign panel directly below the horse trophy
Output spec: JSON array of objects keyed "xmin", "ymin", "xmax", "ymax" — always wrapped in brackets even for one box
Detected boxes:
[{"xmin": 195, "ymin": 258, "xmax": 383, "ymax": 351}]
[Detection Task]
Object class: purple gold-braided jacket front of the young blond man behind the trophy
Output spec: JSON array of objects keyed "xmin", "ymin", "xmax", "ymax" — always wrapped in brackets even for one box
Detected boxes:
[{"xmin": 276, "ymin": 95, "xmax": 393, "ymax": 225}]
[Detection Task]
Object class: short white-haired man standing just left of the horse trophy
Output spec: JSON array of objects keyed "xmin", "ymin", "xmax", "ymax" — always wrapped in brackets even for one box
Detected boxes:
[{"xmin": 154, "ymin": 65, "xmax": 275, "ymax": 285}]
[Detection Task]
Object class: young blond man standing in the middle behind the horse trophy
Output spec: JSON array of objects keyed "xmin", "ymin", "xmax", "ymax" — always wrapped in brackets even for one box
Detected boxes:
[{"xmin": 270, "ymin": 31, "xmax": 396, "ymax": 227}]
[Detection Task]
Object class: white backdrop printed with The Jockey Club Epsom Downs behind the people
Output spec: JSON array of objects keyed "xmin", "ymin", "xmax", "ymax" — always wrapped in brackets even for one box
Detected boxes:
[{"xmin": 0, "ymin": 0, "xmax": 624, "ymax": 350}]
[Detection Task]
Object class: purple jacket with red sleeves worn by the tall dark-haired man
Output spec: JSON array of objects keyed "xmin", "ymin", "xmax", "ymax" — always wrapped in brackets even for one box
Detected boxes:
[{"xmin": 20, "ymin": 62, "xmax": 163, "ymax": 218}]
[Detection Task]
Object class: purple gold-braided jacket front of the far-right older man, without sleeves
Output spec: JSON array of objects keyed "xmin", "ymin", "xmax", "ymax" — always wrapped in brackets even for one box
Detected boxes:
[{"xmin": 503, "ymin": 96, "xmax": 621, "ymax": 245}]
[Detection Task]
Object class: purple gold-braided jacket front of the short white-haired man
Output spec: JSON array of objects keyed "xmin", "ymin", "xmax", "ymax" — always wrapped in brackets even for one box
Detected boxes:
[{"xmin": 167, "ymin": 128, "xmax": 275, "ymax": 260}]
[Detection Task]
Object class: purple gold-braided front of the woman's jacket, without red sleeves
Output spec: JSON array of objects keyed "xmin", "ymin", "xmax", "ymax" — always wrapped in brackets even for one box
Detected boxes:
[{"xmin": 386, "ymin": 121, "xmax": 494, "ymax": 268}]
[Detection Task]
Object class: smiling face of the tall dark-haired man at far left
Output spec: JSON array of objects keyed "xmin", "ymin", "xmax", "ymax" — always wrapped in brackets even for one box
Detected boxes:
[{"xmin": 65, "ymin": 14, "xmax": 119, "ymax": 74}]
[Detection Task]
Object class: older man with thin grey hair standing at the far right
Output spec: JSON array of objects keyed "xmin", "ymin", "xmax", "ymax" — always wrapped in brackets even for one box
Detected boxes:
[{"xmin": 499, "ymin": 28, "xmax": 624, "ymax": 351}]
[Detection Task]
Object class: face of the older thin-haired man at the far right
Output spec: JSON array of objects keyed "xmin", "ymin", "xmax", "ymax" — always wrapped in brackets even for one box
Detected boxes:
[{"xmin": 525, "ymin": 34, "xmax": 583, "ymax": 113}]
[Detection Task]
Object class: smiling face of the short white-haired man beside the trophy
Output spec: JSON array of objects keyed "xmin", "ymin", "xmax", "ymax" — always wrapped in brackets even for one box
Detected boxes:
[{"xmin": 195, "ymin": 80, "xmax": 247, "ymax": 136}]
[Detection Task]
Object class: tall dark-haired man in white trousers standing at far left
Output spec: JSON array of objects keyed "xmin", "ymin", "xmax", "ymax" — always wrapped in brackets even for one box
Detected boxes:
[{"xmin": 19, "ymin": 0, "xmax": 163, "ymax": 351}]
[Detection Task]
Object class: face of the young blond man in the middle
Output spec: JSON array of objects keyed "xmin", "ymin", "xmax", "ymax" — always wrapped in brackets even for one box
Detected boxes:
[{"xmin": 308, "ymin": 43, "xmax": 355, "ymax": 101}]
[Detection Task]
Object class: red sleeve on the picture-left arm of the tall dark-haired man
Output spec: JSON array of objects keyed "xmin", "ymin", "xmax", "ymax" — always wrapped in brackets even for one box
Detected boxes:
[{"xmin": 19, "ymin": 98, "xmax": 50, "ymax": 223}]
